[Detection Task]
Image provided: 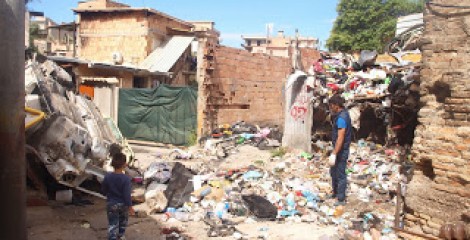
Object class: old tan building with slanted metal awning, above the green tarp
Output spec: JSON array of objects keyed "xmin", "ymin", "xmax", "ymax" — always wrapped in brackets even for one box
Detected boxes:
[{"xmin": 50, "ymin": 0, "xmax": 200, "ymax": 121}]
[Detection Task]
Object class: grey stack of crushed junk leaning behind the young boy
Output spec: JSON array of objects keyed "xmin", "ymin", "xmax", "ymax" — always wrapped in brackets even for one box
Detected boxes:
[{"xmin": 25, "ymin": 56, "xmax": 133, "ymax": 198}]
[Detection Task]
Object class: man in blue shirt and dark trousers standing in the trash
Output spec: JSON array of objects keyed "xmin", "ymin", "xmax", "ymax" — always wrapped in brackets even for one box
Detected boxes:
[{"xmin": 329, "ymin": 95, "xmax": 352, "ymax": 206}]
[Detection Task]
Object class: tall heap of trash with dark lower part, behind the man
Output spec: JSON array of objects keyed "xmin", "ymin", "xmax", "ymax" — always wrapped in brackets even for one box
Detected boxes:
[{"xmin": 307, "ymin": 51, "xmax": 420, "ymax": 145}]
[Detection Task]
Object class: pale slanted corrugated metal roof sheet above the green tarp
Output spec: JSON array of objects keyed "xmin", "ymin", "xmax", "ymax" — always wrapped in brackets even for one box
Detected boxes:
[{"xmin": 140, "ymin": 36, "xmax": 194, "ymax": 72}]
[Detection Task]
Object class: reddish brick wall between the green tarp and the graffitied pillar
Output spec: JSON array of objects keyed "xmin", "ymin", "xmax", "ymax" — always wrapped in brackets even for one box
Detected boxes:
[{"xmin": 198, "ymin": 43, "xmax": 318, "ymax": 133}]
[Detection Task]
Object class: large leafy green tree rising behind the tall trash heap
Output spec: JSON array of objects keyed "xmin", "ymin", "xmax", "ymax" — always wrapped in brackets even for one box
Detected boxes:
[{"xmin": 326, "ymin": 0, "xmax": 424, "ymax": 52}]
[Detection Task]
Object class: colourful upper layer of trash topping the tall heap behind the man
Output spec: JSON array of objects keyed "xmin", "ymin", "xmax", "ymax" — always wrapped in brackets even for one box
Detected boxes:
[{"xmin": 308, "ymin": 50, "xmax": 418, "ymax": 101}]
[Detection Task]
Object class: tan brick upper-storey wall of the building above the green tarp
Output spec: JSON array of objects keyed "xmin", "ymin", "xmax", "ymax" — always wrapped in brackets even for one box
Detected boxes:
[{"xmin": 78, "ymin": 11, "xmax": 191, "ymax": 65}]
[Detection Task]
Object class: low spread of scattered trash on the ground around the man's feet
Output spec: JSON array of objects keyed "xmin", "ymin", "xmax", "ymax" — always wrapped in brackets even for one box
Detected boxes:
[{"xmin": 138, "ymin": 140, "xmax": 407, "ymax": 239}]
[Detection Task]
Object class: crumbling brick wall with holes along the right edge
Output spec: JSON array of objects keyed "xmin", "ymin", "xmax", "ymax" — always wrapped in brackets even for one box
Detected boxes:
[{"xmin": 405, "ymin": 0, "xmax": 470, "ymax": 235}]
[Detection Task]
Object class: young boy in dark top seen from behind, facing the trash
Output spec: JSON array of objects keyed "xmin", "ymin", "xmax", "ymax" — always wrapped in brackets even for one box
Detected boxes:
[{"xmin": 102, "ymin": 153, "xmax": 134, "ymax": 240}]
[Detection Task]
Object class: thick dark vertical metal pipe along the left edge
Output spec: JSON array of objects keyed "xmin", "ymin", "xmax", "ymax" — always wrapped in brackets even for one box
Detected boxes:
[{"xmin": 0, "ymin": 0, "xmax": 27, "ymax": 240}]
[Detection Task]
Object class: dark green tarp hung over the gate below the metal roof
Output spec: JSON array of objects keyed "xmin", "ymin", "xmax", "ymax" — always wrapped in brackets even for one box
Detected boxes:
[{"xmin": 118, "ymin": 85, "xmax": 197, "ymax": 145}]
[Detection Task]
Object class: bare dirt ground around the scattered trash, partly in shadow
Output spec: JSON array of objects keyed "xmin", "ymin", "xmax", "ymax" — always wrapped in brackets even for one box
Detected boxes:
[{"xmin": 27, "ymin": 143, "xmax": 337, "ymax": 240}]
